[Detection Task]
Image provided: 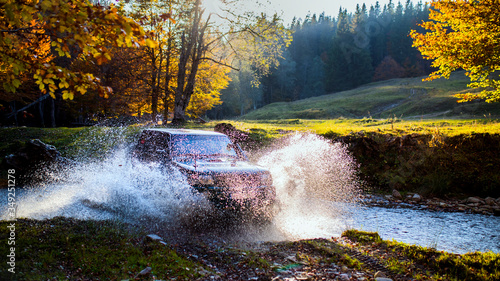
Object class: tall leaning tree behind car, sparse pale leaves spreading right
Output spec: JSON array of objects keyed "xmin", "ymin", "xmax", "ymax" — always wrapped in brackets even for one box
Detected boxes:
[{"xmin": 166, "ymin": 0, "xmax": 291, "ymax": 123}]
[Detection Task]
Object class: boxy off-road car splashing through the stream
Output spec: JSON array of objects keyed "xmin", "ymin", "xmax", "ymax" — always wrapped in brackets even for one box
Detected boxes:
[{"xmin": 133, "ymin": 128, "xmax": 275, "ymax": 211}]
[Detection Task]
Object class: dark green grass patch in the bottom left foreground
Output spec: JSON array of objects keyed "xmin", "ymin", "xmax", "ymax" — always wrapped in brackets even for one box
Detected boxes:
[{"xmin": 0, "ymin": 218, "xmax": 204, "ymax": 280}]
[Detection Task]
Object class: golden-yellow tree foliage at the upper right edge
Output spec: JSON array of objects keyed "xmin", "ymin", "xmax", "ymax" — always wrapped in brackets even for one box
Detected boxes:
[{"xmin": 410, "ymin": 0, "xmax": 500, "ymax": 102}]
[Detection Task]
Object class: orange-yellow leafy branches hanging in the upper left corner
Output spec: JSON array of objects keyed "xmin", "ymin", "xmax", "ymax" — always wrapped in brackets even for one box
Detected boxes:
[{"xmin": 0, "ymin": 0, "xmax": 154, "ymax": 99}]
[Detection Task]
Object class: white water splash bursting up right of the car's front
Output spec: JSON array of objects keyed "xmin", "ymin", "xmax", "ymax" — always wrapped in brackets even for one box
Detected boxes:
[{"xmin": 259, "ymin": 134, "xmax": 360, "ymax": 239}]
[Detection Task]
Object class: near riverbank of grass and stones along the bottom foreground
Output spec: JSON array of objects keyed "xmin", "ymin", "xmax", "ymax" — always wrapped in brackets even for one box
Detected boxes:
[{"xmin": 0, "ymin": 218, "xmax": 500, "ymax": 280}]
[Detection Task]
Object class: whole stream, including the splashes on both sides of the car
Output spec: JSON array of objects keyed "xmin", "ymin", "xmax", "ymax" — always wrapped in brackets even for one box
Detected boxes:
[{"xmin": 0, "ymin": 130, "xmax": 500, "ymax": 253}]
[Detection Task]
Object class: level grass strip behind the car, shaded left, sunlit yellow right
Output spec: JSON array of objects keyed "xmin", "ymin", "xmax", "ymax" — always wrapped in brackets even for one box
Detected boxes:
[{"xmin": 0, "ymin": 118, "xmax": 500, "ymax": 157}]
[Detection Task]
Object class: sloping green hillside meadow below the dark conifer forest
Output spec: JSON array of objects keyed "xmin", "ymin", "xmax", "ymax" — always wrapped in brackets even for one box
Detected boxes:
[{"xmin": 242, "ymin": 72, "xmax": 500, "ymax": 120}]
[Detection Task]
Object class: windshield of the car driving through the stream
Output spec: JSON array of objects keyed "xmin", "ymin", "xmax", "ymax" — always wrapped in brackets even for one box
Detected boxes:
[{"xmin": 172, "ymin": 135, "xmax": 237, "ymax": 157}]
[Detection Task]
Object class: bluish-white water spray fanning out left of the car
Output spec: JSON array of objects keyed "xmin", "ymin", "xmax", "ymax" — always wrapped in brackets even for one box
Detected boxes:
[{"xmin": 2, "ymin": 149, "xmax": 209, "ymax": 223}]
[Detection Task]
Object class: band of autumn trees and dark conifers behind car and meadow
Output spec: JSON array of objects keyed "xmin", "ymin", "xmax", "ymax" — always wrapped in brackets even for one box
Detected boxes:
[{"xmin": 0, "ymin": 0, "xmax": 431, "ymax": 124}]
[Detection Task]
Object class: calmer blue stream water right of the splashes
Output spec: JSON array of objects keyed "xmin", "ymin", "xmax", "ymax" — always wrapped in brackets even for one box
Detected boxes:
[{"xmin": 351, "ymin": 207, "xmax": 500, "ymax": 254}]
